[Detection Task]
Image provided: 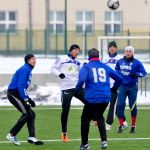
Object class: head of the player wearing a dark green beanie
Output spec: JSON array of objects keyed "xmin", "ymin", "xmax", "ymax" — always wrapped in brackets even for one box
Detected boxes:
[{"xmin": 108, "ymin": 41, "xmax": 118, "ymax": 55}]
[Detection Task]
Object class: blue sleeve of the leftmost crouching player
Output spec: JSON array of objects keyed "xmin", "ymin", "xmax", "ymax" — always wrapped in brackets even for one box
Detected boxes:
[{"xmin": 18, "ymin": 69, "xmax": 30, "ymax": 100}]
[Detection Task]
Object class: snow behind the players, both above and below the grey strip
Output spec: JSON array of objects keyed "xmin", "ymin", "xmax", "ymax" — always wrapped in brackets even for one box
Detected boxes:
[{"xmin": 0, "ymin": 57, "xmax": 150, "ymax": 106}]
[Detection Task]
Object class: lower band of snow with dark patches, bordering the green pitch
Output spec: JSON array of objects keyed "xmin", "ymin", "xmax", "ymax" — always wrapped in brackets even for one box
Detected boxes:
[{"xmin": 0, "ymin": 84, "xmax": 150, "ymax": 106}]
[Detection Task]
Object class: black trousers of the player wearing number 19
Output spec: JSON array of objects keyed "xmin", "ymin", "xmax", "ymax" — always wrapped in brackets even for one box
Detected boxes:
[{"xmin": 81, "ymin": 103, "xmax": 108, "ymax": 145}]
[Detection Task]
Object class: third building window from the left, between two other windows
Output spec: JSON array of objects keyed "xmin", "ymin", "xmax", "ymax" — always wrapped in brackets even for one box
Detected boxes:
[{"xmin": 76, "ymin": 11, "xmax": 94, "ymax": 34}]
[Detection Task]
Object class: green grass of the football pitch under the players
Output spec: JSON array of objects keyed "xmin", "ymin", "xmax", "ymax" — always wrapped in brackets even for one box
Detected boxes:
[{"xmin": 0, "ymin": 106, "xmax": 150, "ymax": 150}]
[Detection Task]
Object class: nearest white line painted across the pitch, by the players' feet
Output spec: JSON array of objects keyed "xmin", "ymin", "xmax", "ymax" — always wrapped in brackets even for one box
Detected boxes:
[{"xmin": 0, "ymin": 138, "xmax": 150, "ymax": 144}]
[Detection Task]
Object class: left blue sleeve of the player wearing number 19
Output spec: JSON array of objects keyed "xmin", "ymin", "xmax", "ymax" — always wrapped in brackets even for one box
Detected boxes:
[{"xmin": 76, "ymin": 65, "xmax": 88, "ymax": 91}]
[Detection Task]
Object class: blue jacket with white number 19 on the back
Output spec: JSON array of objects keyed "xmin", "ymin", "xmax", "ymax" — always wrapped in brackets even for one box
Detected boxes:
[{"xmin": 76, "ymin": 59, "xmax": 122, "ymax": 103}]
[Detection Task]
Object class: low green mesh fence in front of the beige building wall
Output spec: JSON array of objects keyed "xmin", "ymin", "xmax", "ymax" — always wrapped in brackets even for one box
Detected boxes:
[{"xmin": 0, "ymin": 29, "xmax": 150, "ymax": 57}]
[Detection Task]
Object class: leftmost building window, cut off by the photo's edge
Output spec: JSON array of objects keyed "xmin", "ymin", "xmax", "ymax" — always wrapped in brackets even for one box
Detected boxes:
[{"xmin": 0, "ymin": 11, "xmax": 17, "ymax": 33}]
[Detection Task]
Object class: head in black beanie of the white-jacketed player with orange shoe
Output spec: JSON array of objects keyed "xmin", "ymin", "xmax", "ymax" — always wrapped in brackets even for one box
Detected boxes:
[{"xmin": 69, "ymin": 44, "xmax": 80, "ymax": 58}]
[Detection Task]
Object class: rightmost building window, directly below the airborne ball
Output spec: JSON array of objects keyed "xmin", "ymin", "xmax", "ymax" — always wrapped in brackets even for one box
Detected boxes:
[{"xmin": 104, "ymin": 11, "xmax": 122, "ymax": 35}]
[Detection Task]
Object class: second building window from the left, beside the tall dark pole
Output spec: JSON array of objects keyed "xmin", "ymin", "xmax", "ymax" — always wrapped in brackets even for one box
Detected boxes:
[{"xmin": 48, "ymin": 11, "xmax": 64, "ymax": 34}]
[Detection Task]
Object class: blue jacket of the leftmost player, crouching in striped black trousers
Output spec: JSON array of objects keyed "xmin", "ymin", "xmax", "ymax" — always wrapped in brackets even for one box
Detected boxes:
[{"xmin": 8, "ymin": 63, "xmax": 33, "ymax": 100}]
